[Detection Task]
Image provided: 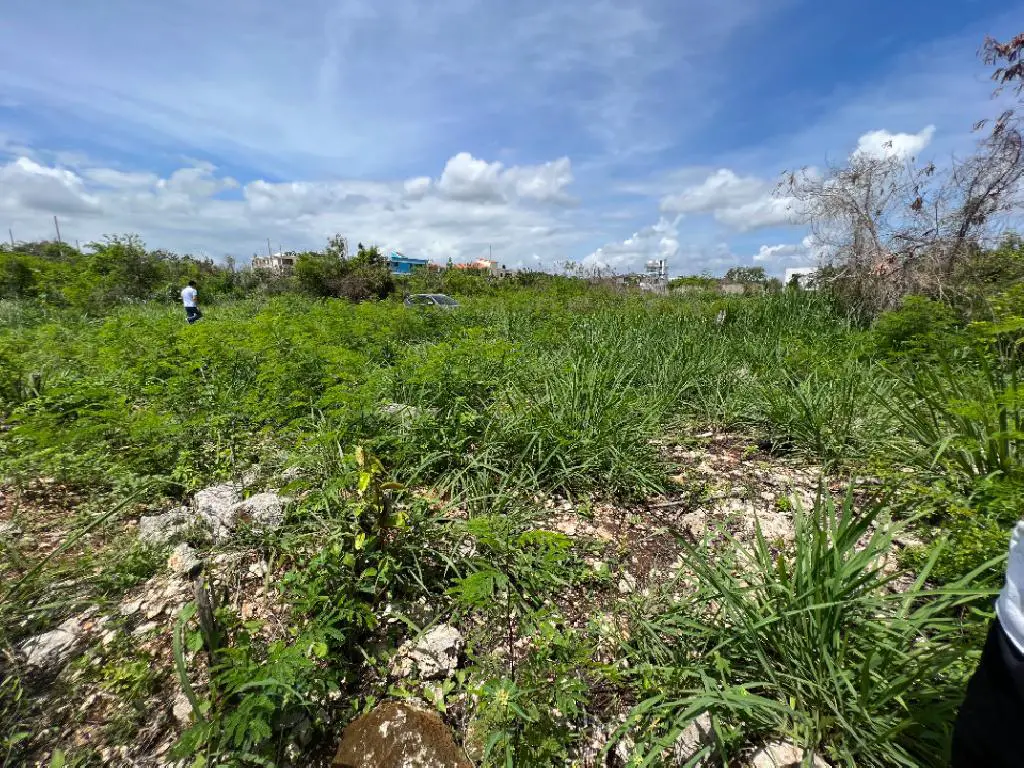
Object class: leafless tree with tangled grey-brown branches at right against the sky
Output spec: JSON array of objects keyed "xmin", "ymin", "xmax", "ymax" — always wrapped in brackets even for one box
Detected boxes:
[{"xmin": 778, "ymin": 91, "xmax": 1024, "ymax": 318}]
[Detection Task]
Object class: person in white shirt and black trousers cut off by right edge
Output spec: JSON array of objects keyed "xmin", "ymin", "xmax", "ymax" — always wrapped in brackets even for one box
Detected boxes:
[{"xmin": 952, "ymin": 521, "xmax": 1024, "ymax": 768}]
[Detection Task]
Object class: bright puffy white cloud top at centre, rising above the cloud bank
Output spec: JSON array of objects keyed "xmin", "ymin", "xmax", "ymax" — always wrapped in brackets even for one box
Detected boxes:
[{"xmin": 437, "ymin": 152, "xmax": 572, "ymax": 203}]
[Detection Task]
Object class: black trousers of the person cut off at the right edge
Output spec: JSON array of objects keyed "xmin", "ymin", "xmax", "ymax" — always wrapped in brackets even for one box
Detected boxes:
[{"xmin": 952, "ymin": 620, "xmax": 1024, "ymax": 768}]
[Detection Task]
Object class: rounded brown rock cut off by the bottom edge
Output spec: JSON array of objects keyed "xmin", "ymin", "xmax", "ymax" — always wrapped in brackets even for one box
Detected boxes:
[{"xmin": 332, "ymin": 701, "xmax": 472, "ymax": 768}]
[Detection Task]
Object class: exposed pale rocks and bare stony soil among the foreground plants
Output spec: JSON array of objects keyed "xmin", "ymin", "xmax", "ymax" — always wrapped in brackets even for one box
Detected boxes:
[{"xmin": 0, "ymin": 433, "xmax": 912, "ymax": 768}]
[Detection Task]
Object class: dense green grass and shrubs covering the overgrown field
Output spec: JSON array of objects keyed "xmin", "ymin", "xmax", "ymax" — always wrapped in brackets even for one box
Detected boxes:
[{"xmin": 0, "ymin": 225, "xmax": 1024, "ymax": 766}]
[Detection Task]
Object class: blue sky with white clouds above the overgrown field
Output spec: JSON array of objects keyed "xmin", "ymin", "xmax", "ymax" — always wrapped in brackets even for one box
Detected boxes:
[{"xmin": 0, "ymin": 0, "xmax": 1024, "ymax": 274}]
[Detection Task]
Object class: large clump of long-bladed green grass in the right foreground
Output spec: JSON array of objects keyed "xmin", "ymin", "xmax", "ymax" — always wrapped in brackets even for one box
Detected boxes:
[{"xmin": 629, "ymin": 496, "xmax": 1001, "ymax": 767}]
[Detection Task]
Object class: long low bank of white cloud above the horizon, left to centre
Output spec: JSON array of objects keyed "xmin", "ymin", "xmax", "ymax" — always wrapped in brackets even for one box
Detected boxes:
[{"xmin": 0, "ymin": 148, "xmax": 583, "ymax": 263}]
